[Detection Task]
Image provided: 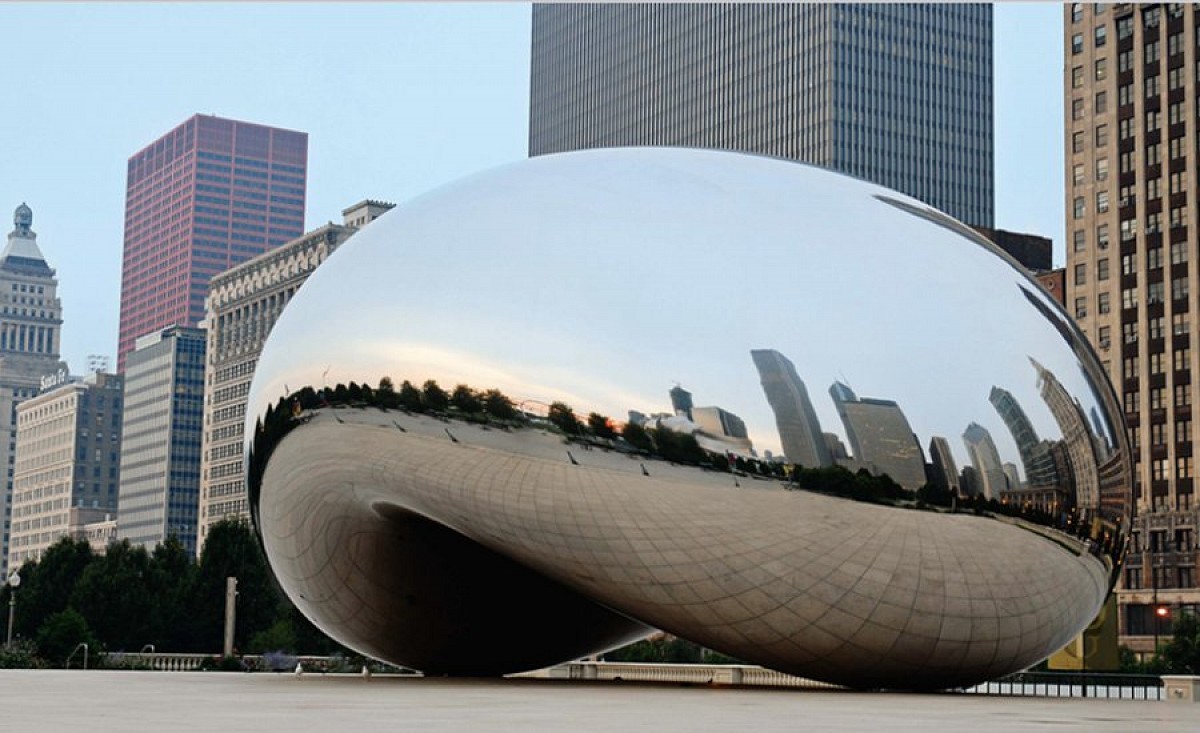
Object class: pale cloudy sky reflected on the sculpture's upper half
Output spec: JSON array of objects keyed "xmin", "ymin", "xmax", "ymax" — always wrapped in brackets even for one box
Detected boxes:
[{"xmin": 243, "ymin": 150, "xmax": 1123, "ymax": 513}]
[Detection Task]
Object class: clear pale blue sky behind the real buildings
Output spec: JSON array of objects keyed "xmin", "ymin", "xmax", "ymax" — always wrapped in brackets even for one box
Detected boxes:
[{"xmin": 0, "ymin": 2, "xmax": 1063, "ymax": 372}]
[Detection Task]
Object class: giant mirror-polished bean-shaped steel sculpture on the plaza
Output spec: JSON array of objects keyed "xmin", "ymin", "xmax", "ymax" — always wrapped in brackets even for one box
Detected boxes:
[{"xmin": 246, "ymin": 149, "xmax": 1130, "ymax": 689}]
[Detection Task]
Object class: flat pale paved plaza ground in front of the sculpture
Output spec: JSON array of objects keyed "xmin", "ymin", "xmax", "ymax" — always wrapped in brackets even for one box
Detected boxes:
[{"xmin": 0, "ymin": 671, "xmax": 1200, "ymax": 733}]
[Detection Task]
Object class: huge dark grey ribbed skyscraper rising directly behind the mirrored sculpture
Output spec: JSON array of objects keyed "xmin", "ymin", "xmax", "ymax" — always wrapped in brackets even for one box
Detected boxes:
[{"xmin": 529, "ymin": 2, "xmax": 994, "ymax": 227}]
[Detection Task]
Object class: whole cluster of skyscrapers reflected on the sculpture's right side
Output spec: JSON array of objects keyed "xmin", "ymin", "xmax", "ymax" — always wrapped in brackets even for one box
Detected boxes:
[{"xmin": 751, "ymin": 349, "xmax": 1109, "ymax": 511}]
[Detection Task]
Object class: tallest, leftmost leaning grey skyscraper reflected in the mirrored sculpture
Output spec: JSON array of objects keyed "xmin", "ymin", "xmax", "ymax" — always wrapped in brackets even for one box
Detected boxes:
[{"xmin": 750, "ymin": 349, "xmax": 833, "ymax": 468}]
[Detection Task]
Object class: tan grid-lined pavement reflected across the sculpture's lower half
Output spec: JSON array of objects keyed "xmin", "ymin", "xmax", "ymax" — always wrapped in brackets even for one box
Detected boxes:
[{"xmin": 263, "ymin": 410, "xmax": 1106, "ymax": 686}]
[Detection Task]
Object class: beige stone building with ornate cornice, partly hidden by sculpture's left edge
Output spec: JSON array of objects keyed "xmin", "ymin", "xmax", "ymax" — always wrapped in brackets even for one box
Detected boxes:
[{"xmin": 198, "ymin": 199, "xmax": 394, "ymax": 547}]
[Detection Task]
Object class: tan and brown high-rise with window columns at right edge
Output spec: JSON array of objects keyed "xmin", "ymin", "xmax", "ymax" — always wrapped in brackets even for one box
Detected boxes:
[{"xmin": 1063, "ymin": 4, "xmax": 1200, "ymax": 651}]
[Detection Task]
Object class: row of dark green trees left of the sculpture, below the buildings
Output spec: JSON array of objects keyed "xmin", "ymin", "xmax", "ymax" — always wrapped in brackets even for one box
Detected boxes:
[{"xmin": 0, "ymin": 519, "xmax": 347, "ymax": 667}]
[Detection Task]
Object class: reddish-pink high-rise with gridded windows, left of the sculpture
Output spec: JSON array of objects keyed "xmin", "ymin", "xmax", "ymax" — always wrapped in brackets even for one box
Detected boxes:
[{"xmin": 116, "ymin": 115, "xmax": 308, "ymax": 372}]
